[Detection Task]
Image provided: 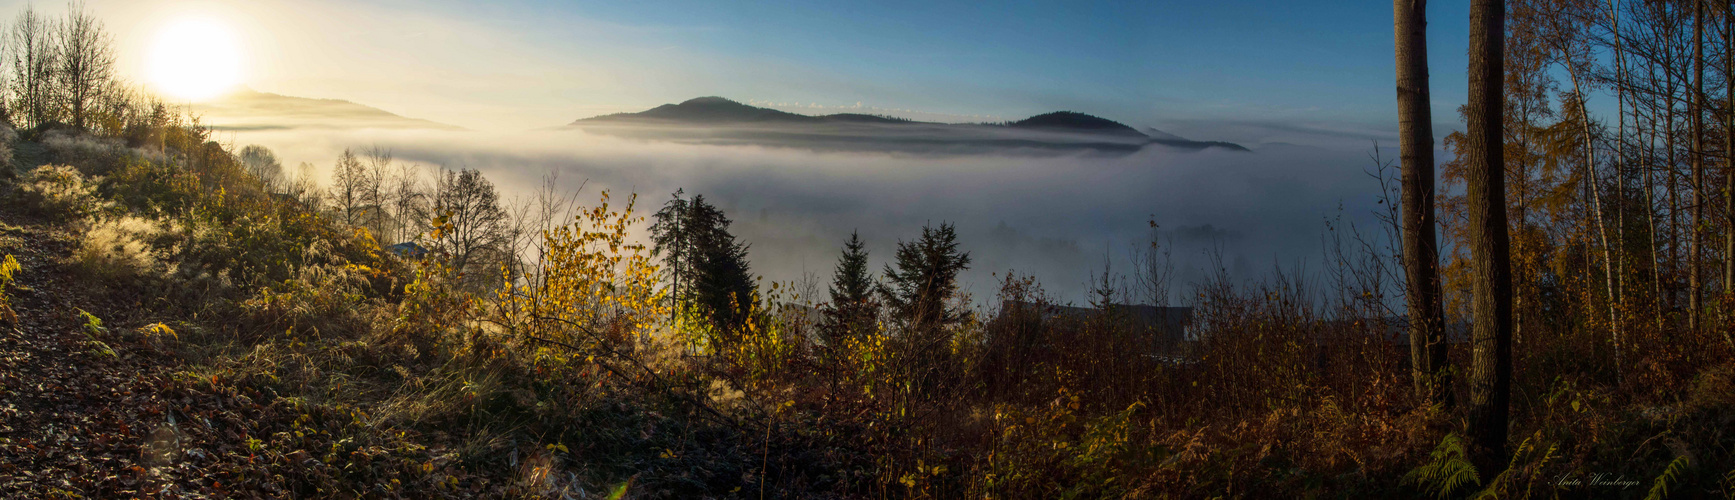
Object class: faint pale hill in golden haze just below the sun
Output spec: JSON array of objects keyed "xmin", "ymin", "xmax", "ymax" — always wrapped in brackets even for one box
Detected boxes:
[{"xmin": 189, "ymin": 89, "xmax": 463, "ymax": 130}]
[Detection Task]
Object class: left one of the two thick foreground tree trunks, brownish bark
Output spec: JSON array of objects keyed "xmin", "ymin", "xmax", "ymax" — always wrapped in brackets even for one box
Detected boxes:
[{"xmin": 1391, "ymin": 0, "xmax": 1452, "ymax": 406}]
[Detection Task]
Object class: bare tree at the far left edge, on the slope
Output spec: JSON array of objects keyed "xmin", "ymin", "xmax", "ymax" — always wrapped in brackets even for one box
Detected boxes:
[{"xmin": 5, "ymin": 3, "xmax": 59, "ymax": 128}]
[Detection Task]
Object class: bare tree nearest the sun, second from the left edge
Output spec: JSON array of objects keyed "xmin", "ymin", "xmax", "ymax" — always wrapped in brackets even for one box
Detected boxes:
[{"xmin": 54, "ymin": 2, "xmax": 115, "ymax": 130}]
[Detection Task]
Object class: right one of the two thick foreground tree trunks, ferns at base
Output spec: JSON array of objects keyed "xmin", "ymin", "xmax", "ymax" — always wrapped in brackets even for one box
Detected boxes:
[{"xmin": 1464, "ymin": 0, "xmax": 1513, "ymax": 477}]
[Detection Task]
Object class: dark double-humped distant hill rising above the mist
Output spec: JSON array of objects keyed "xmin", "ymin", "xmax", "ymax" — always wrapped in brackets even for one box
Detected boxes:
[{"xmin": 567, "ymin": 97, "xmax": 1247, "ymax": 155}]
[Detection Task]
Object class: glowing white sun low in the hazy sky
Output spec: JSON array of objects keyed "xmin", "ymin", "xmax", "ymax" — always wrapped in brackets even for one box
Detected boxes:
[{"xmin": 149, "ymin": 17, "xmax": 243, "ymax": 101}]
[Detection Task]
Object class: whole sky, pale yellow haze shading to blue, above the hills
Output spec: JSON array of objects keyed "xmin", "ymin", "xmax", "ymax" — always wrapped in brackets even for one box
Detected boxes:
[{"xmin": 0, "ymin": 0, "xmax": 1468, "ymax": 144}]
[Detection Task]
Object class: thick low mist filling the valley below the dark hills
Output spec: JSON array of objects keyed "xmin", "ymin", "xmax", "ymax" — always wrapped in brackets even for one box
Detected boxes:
[{"xmin": 219, "ymin": 128, "xmax": 1379, "ymax": 302}]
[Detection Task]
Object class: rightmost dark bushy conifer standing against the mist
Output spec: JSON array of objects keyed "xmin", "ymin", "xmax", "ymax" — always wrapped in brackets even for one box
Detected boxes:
[{"xmin": 880, "ymin": 222, "xmax": 970, "ymax": 332}]
